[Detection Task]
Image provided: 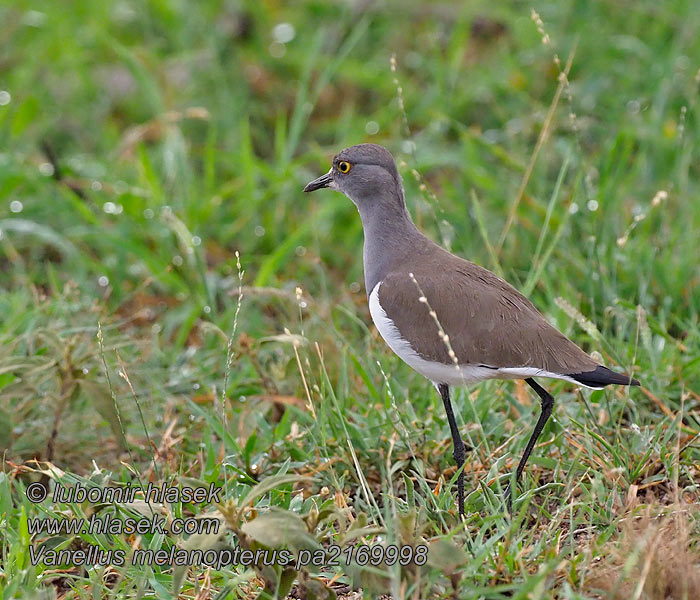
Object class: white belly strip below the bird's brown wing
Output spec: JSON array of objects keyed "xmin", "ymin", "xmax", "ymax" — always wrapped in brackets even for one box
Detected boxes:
[{"xmin": 369, "ymin": 281, "xmax": 584, "ymax": 389}]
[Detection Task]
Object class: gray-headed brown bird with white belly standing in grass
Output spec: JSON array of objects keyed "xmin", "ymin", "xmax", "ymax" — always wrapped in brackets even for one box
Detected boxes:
[{"xmin": 304, "ymin": 144, "xmax": 639, "ymax": 517}]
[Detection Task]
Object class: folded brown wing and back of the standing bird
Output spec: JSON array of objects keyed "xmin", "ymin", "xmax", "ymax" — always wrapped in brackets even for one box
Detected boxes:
[{"xmin": 379, "ymin": 246, "xmax": 598, "ymax": 374}]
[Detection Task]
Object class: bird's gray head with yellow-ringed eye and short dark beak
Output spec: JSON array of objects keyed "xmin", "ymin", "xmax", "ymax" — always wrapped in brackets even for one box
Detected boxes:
[{"xmin": 304, "ymin": 144, "xmax": 405, "ymax": 213}]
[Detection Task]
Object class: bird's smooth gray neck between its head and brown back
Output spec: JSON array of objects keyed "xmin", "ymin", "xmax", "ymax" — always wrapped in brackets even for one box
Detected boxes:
[{"xmin": 356, "ymin": 187, "xmax": 423, "ymax": 296}]
